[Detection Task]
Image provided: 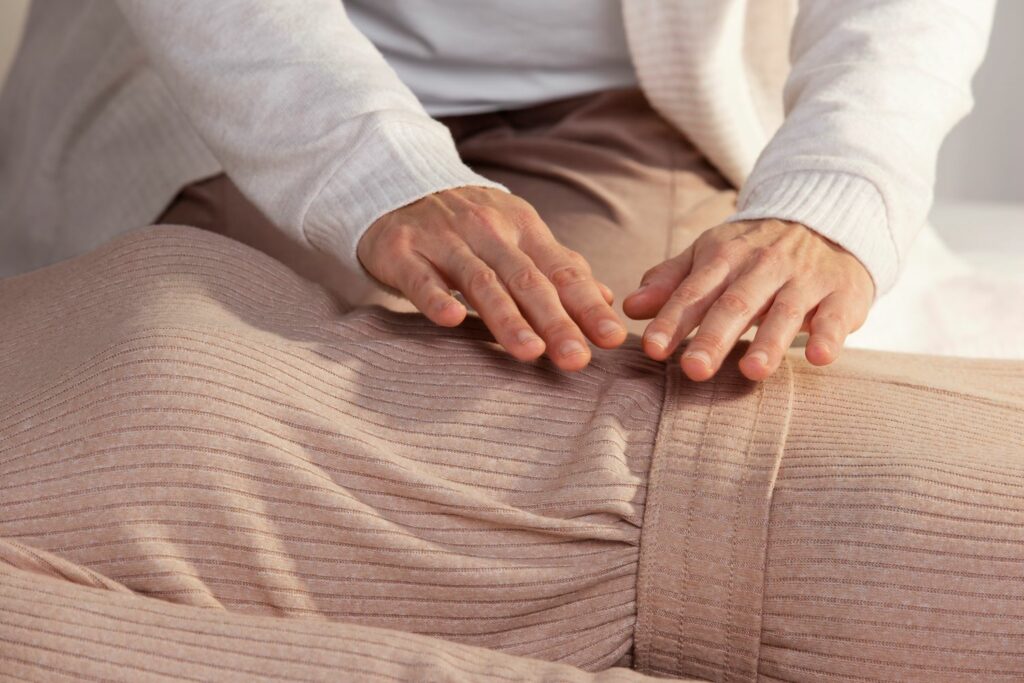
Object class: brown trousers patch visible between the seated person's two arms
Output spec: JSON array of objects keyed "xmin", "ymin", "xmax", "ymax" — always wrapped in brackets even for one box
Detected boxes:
[{"xmin": 441, "ymin": 89, "xmax": 735, "ymax": 333}]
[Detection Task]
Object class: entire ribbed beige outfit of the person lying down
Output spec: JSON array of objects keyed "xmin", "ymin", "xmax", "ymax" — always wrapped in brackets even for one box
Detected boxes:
[{"xmin": 0, "ymin": 227, "xmax": 1024, "ymax": 681}]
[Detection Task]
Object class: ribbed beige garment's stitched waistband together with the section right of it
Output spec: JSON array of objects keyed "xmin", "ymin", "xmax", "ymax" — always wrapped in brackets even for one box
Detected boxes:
[{"xmin": 635, "ymin": 345, "xmax": 1024, "ymax": 681}]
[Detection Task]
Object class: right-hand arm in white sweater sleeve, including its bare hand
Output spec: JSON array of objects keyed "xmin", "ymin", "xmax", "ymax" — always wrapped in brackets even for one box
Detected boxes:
[{"xmin": 624, "ymin": 0, "xmax": 993, "ymax": 381}]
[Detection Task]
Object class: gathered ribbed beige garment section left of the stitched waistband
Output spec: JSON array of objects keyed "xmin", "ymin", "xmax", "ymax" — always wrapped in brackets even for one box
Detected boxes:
[{"xmin": 0, "ymin": 227, "xmax": 664, "ymax": 669}]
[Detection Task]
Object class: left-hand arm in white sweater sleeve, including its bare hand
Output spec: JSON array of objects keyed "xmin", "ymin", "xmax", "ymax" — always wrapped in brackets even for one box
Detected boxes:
[{"xmin": 120, "ymin": 0, "xmax": 626, "ymax": 370}]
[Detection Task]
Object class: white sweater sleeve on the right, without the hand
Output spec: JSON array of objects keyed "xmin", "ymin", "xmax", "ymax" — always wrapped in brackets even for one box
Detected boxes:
[{"xmin": 730, "ymin": 0, "xmax": 994, "ymax": 295}]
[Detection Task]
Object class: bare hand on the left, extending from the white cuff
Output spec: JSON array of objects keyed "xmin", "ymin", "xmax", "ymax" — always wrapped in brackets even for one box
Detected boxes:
[{"xmin": 356, "ymin": 186, "xmax": 626, "ymax": 370}]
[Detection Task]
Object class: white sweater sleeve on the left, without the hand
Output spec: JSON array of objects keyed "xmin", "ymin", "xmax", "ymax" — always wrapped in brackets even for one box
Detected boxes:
[{"xmin": 120, "ymin": 0, "xmax": 507, "ymax": 278}]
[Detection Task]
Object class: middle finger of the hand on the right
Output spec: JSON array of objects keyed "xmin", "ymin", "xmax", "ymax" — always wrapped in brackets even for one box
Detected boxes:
[{"xmin": 680, "ymin": 266, "xmax": 785, "ymax": 382}]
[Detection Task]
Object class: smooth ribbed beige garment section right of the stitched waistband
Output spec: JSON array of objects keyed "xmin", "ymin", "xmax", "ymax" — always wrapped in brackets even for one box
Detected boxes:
[{"xmin": 760, "ymin": 351, "xmax": 1024, "ymax": 681}]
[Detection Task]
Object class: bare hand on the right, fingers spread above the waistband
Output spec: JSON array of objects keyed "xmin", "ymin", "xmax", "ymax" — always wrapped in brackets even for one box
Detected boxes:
[{"xmin": 623, "ymin": 219, "xmax": 874, "ymax": 382}]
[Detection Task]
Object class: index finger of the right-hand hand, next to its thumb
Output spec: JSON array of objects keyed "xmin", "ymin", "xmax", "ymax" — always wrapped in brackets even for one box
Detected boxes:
[{"xmin": 643, "ymin": 253, "xmax": 731, "ymax": 360}]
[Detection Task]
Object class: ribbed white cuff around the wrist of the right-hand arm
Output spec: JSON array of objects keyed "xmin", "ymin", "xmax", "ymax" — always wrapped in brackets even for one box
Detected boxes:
[{"xmin": 727, "ymin": 170, "xmax": 900, "ymax": 297}]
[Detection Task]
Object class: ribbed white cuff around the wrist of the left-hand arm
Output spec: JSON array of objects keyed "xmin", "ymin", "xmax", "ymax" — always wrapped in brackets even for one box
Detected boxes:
[{"xmin": 303, "ymin": 119, "xmax": 508, "ymax": 293}]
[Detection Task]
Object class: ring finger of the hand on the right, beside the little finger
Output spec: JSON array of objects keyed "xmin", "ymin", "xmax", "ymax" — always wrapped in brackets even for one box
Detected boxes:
[{"xmin": 739, "ymin": 284, "xmax": 817, "ymax": 381}]
